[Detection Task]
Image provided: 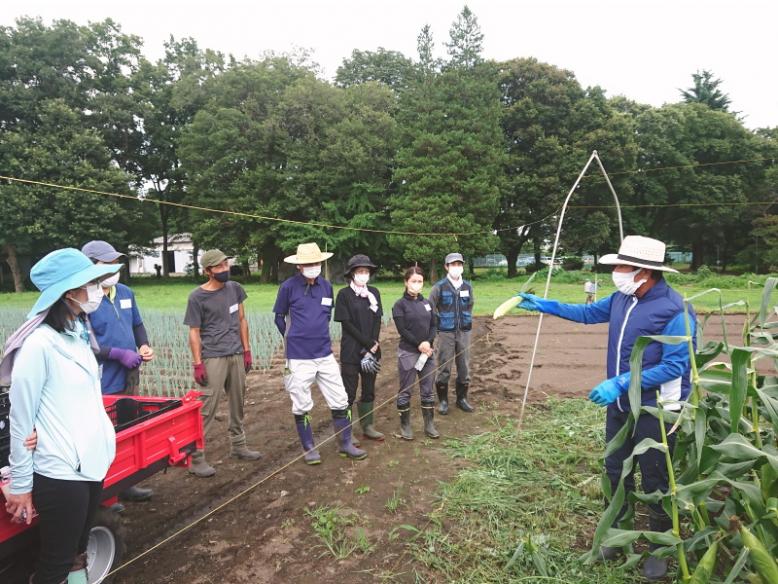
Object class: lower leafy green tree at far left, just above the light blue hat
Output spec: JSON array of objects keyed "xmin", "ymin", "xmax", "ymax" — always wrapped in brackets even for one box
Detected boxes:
[{"xmin": 0, "ymin": 99, "xmax": 153, "ymax": 292}]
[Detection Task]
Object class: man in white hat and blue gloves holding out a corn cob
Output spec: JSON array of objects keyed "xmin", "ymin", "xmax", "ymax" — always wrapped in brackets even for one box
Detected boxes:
[{"xmin": 519, "ymin": 235, "xmax": 696, "ymax": 580}]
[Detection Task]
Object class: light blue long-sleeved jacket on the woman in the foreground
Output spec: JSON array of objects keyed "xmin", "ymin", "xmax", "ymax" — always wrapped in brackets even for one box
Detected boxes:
[{"xmin": 10, "ymin": 320, "xmax": 116, "ymax": 495}]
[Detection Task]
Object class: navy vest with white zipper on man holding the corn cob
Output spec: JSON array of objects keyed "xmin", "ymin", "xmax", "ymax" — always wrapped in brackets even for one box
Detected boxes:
[{"xmin": 608, "ymin": 279, "xmax": 696, "ymax": 412}]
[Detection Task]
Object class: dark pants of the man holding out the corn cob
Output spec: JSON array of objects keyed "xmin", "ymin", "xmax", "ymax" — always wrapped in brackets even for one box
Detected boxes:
[{"xmin": 605, "ymin": 406, "xmax": 675, "ymax": 517}]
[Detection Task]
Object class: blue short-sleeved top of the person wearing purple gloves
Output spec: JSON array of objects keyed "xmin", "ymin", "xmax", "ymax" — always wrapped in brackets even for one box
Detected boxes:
[{"xmin": 89, "ymin": 284, "xmax": 143, "ymax": 394}]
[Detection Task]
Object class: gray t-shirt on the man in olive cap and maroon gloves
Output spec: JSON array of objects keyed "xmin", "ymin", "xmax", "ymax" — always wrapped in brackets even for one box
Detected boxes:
[{"xmin": 184, "ymin": 280, "xmax": 246, "ymax": 359}]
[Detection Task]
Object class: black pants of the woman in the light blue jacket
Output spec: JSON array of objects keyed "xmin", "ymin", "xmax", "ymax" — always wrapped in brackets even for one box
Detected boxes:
[{"xmin": 32, "ymin": 473, "xmax": 103, "ymax": 584}]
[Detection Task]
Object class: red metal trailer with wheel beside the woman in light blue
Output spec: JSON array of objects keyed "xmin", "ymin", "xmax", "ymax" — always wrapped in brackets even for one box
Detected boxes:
[{"xmin": 0, "ymin": 391, "xmax": 203, "ymax": 584}]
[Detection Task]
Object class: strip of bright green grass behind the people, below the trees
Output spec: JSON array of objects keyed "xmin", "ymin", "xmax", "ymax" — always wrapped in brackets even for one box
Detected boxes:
[{"xmin": 0, "ymin": 272, "xmax": 764, "ymax": 315}]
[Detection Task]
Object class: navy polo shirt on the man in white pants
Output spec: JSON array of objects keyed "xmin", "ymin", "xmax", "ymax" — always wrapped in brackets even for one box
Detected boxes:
[{"xmin": 273, "ymin": 272, "xmax": 333, "ymax": 359}]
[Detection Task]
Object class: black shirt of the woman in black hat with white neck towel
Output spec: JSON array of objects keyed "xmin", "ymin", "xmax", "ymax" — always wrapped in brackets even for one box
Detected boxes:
[{"xmin": 335, "ymin": 286, "xmax": 383, "ymax": 364}]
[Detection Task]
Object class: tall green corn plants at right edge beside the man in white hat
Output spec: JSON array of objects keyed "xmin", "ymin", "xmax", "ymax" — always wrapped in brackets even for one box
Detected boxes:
[{"xmin": 585, "ymin": 278, "xmax": 778, "ymax": 584}]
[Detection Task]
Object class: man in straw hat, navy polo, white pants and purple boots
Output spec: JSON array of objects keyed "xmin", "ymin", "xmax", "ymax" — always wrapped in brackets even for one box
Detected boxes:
[{"xmin": 273, "ymin": 243, "xmax": 367, "ymax": 465}]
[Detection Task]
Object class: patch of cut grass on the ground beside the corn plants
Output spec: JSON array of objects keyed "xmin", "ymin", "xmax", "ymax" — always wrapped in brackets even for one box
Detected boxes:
[{"xmin": 398, "ymin": 400, "xmax": 638, "ymax": 584}]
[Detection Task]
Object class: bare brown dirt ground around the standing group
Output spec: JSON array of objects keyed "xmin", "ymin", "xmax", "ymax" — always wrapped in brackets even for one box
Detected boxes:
[{"xmin": 110, "ymin": 317, "xmax": 742, "ymax": 584}]
